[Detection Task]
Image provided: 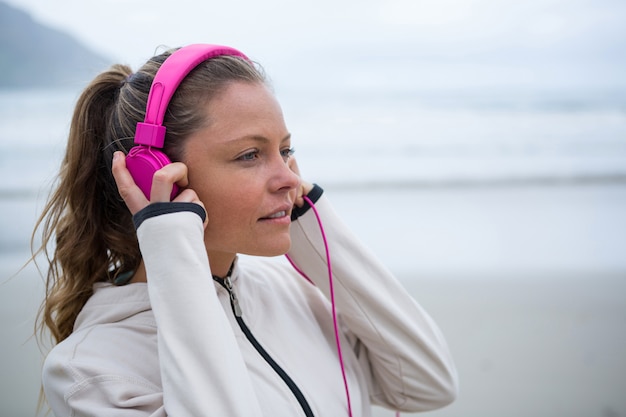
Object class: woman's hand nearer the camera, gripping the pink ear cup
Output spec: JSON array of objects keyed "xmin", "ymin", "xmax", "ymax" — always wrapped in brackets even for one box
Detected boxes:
[{"xmin": 111, "ymin": 151, "xmax": 208, "ymax": 227}]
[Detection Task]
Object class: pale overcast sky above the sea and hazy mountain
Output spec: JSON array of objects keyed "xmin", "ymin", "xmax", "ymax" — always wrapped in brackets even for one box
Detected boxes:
[{"xmin": 5, "ymin": 0, "xmax": 626, "ymax": 93}]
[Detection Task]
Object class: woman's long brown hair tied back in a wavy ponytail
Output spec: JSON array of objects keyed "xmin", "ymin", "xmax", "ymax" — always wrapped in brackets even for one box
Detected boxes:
[{"xmin": 31, "ymin": 47, "xmax": 267, "ymax": 343}]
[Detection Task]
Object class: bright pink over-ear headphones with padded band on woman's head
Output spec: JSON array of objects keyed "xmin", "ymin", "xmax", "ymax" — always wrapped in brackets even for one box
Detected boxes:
[{"xmin": 126, "ymin": 44, "xmax": 248, "ymax": 199}]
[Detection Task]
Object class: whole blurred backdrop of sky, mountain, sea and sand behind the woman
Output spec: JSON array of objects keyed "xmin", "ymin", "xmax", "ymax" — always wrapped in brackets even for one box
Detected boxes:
[{"xmin": 0, "ymin": 0, "xmax": 626, "ymax": 417}]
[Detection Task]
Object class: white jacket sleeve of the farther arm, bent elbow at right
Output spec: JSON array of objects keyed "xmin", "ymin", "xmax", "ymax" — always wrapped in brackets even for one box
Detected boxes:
[{"xmin": 289, "ymin": 197, "xmax": 458, "ymax": 412}]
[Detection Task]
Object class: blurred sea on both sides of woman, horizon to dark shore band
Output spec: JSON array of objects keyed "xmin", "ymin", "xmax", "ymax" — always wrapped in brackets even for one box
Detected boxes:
[{"xmin": 0, "ymin": 86, "xmax": 626, "ymax": 196}]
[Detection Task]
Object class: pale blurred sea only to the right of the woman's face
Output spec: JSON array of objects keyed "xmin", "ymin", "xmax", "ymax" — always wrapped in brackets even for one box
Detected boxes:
[{"xmin": 278, "ymin": 88, "xmax": 626, "ymax": 187}]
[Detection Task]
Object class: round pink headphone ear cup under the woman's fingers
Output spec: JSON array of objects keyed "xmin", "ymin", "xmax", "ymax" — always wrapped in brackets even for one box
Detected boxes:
[{"xmin": 126, "ymin": 145, "xmax": 179, "ymax": 200}]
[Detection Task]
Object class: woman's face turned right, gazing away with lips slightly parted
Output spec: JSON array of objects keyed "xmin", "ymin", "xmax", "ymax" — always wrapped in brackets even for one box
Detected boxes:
[{"xmin": 183, "ymin": 82, "xmax": 300, "ymax": 264}]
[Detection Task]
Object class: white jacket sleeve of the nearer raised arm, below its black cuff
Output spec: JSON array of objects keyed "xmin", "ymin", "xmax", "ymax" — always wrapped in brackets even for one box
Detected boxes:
[{"xmin": 137, "ymin": 211, "xmax": 261, "ymax": 417}]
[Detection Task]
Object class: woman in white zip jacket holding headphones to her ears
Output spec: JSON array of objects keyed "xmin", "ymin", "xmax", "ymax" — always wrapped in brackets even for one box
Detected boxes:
[{"xmin": 33, "ymin": 46, "xmax": 457, "ymax": 417}]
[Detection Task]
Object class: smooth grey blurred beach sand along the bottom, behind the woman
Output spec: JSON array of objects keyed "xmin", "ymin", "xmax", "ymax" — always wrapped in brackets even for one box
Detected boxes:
[{"xmin": 0, "ymin": 260, "xmax": 626, "ymax": 417}]
